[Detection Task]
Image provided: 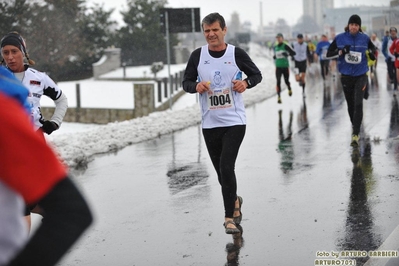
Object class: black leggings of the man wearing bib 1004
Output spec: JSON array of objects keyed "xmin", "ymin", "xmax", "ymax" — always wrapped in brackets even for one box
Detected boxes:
[{"xmin": 202, "ymin": 125, "xmax": 246, "ymax": 218}]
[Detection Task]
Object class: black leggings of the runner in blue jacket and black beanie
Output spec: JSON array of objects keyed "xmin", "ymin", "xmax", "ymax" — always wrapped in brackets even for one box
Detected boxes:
[{"xmin": 341, "ymin": 75, "xmax": 368, "ymax": 135}]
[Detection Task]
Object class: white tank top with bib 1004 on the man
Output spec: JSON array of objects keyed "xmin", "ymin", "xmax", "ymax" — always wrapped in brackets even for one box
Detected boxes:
[{"xmin": 198, "ymin": 44, "xmax": 246, "ymax": 128}]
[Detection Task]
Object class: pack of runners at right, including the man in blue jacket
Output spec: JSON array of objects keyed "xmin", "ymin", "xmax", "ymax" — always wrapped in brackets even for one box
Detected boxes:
[{"xmin": 267, "ymin": 14, "xmax": 399, "ymax": 146}]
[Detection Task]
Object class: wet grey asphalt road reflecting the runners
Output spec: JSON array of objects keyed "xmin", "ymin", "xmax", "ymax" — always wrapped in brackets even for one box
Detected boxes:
[{"xmin": 60, "ymin": 60, "xmax": 399, "ymax": 266}]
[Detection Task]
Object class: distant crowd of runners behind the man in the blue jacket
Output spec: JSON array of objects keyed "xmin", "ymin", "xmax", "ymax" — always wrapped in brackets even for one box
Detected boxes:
[{"xmin": 266, "ymin": 27, "xmax": 399, "ymax": 103}]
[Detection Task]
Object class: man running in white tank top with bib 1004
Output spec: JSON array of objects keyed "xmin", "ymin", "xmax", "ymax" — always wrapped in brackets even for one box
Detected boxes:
[{"xmin": 183, "ymin": 13, "xmax": 262, "ymax": 234}]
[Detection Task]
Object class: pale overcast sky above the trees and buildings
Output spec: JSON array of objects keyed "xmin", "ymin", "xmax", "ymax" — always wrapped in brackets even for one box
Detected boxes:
[{"xmin": 87, "ymin": 0, "xmax": 390, "ymax": 30}]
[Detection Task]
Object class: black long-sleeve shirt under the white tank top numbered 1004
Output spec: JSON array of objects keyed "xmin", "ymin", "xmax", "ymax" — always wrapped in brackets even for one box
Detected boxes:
[{"xmin": 183, "ymin": 44, "xmax": 262, "ymax": 93}]
